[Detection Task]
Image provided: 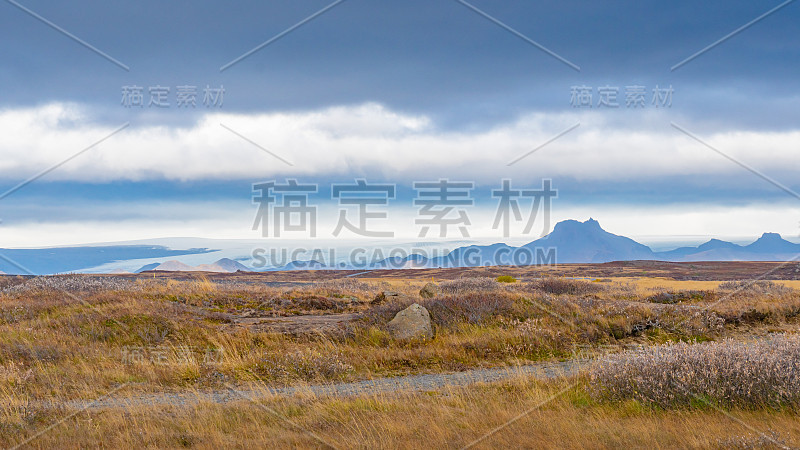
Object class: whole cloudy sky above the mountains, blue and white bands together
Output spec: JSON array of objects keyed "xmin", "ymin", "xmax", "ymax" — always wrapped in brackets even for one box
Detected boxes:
[{"xmin": 0, "ymin": 0, "xmax": 800, "ymax": 248}]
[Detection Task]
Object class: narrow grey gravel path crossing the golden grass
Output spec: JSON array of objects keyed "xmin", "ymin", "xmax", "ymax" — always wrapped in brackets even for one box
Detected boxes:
[{"xmin": 65, "ymin": 360, "xmax": 590, "ymax": 410}]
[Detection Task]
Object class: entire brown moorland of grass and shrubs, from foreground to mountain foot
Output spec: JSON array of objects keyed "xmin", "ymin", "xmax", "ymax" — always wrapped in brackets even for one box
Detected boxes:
[{"xmin": 0, "ymin": 266, "xmax": 800, "ymax": 448}]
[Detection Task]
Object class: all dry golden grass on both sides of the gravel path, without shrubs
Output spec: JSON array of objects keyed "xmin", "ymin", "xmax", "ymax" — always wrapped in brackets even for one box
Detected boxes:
[{"xmin": 0, "ymin": 278, "xmax": 800, "ymax": 448}]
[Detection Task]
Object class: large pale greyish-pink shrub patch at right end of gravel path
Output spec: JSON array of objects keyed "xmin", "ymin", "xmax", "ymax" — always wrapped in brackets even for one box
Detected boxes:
[{"xmin": 589, "ymin": 336, "xmax": 800, "ymax": 408}]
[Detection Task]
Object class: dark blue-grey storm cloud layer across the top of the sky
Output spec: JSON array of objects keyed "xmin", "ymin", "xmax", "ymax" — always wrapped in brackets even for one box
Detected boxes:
[{"xmin": 0, "ymin": 0, "xmax": 800, "ymax": 128}]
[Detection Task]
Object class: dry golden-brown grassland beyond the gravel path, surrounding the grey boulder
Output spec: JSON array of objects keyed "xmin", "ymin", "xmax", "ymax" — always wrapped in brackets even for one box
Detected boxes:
[{"xmin": 0, "ymin": 274, "xmax": 800, "ymax": 398}]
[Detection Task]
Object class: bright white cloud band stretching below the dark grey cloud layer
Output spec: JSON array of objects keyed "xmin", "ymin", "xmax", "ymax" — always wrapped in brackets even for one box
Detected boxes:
[{"xmin": 0, "ymin": 104, "xmax": 800, "ymax": 182}]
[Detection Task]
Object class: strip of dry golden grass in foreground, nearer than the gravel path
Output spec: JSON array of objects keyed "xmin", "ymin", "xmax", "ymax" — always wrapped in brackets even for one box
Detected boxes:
[{"xmin": 0, "ymin": 380, "xmax": 800, "ymax": 449}]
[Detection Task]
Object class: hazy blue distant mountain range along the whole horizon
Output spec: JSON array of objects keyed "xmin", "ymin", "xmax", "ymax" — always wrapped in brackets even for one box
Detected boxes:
[{"xmin": 0, "ymin": 219, "xmax": 800, "ymax": 275}]
